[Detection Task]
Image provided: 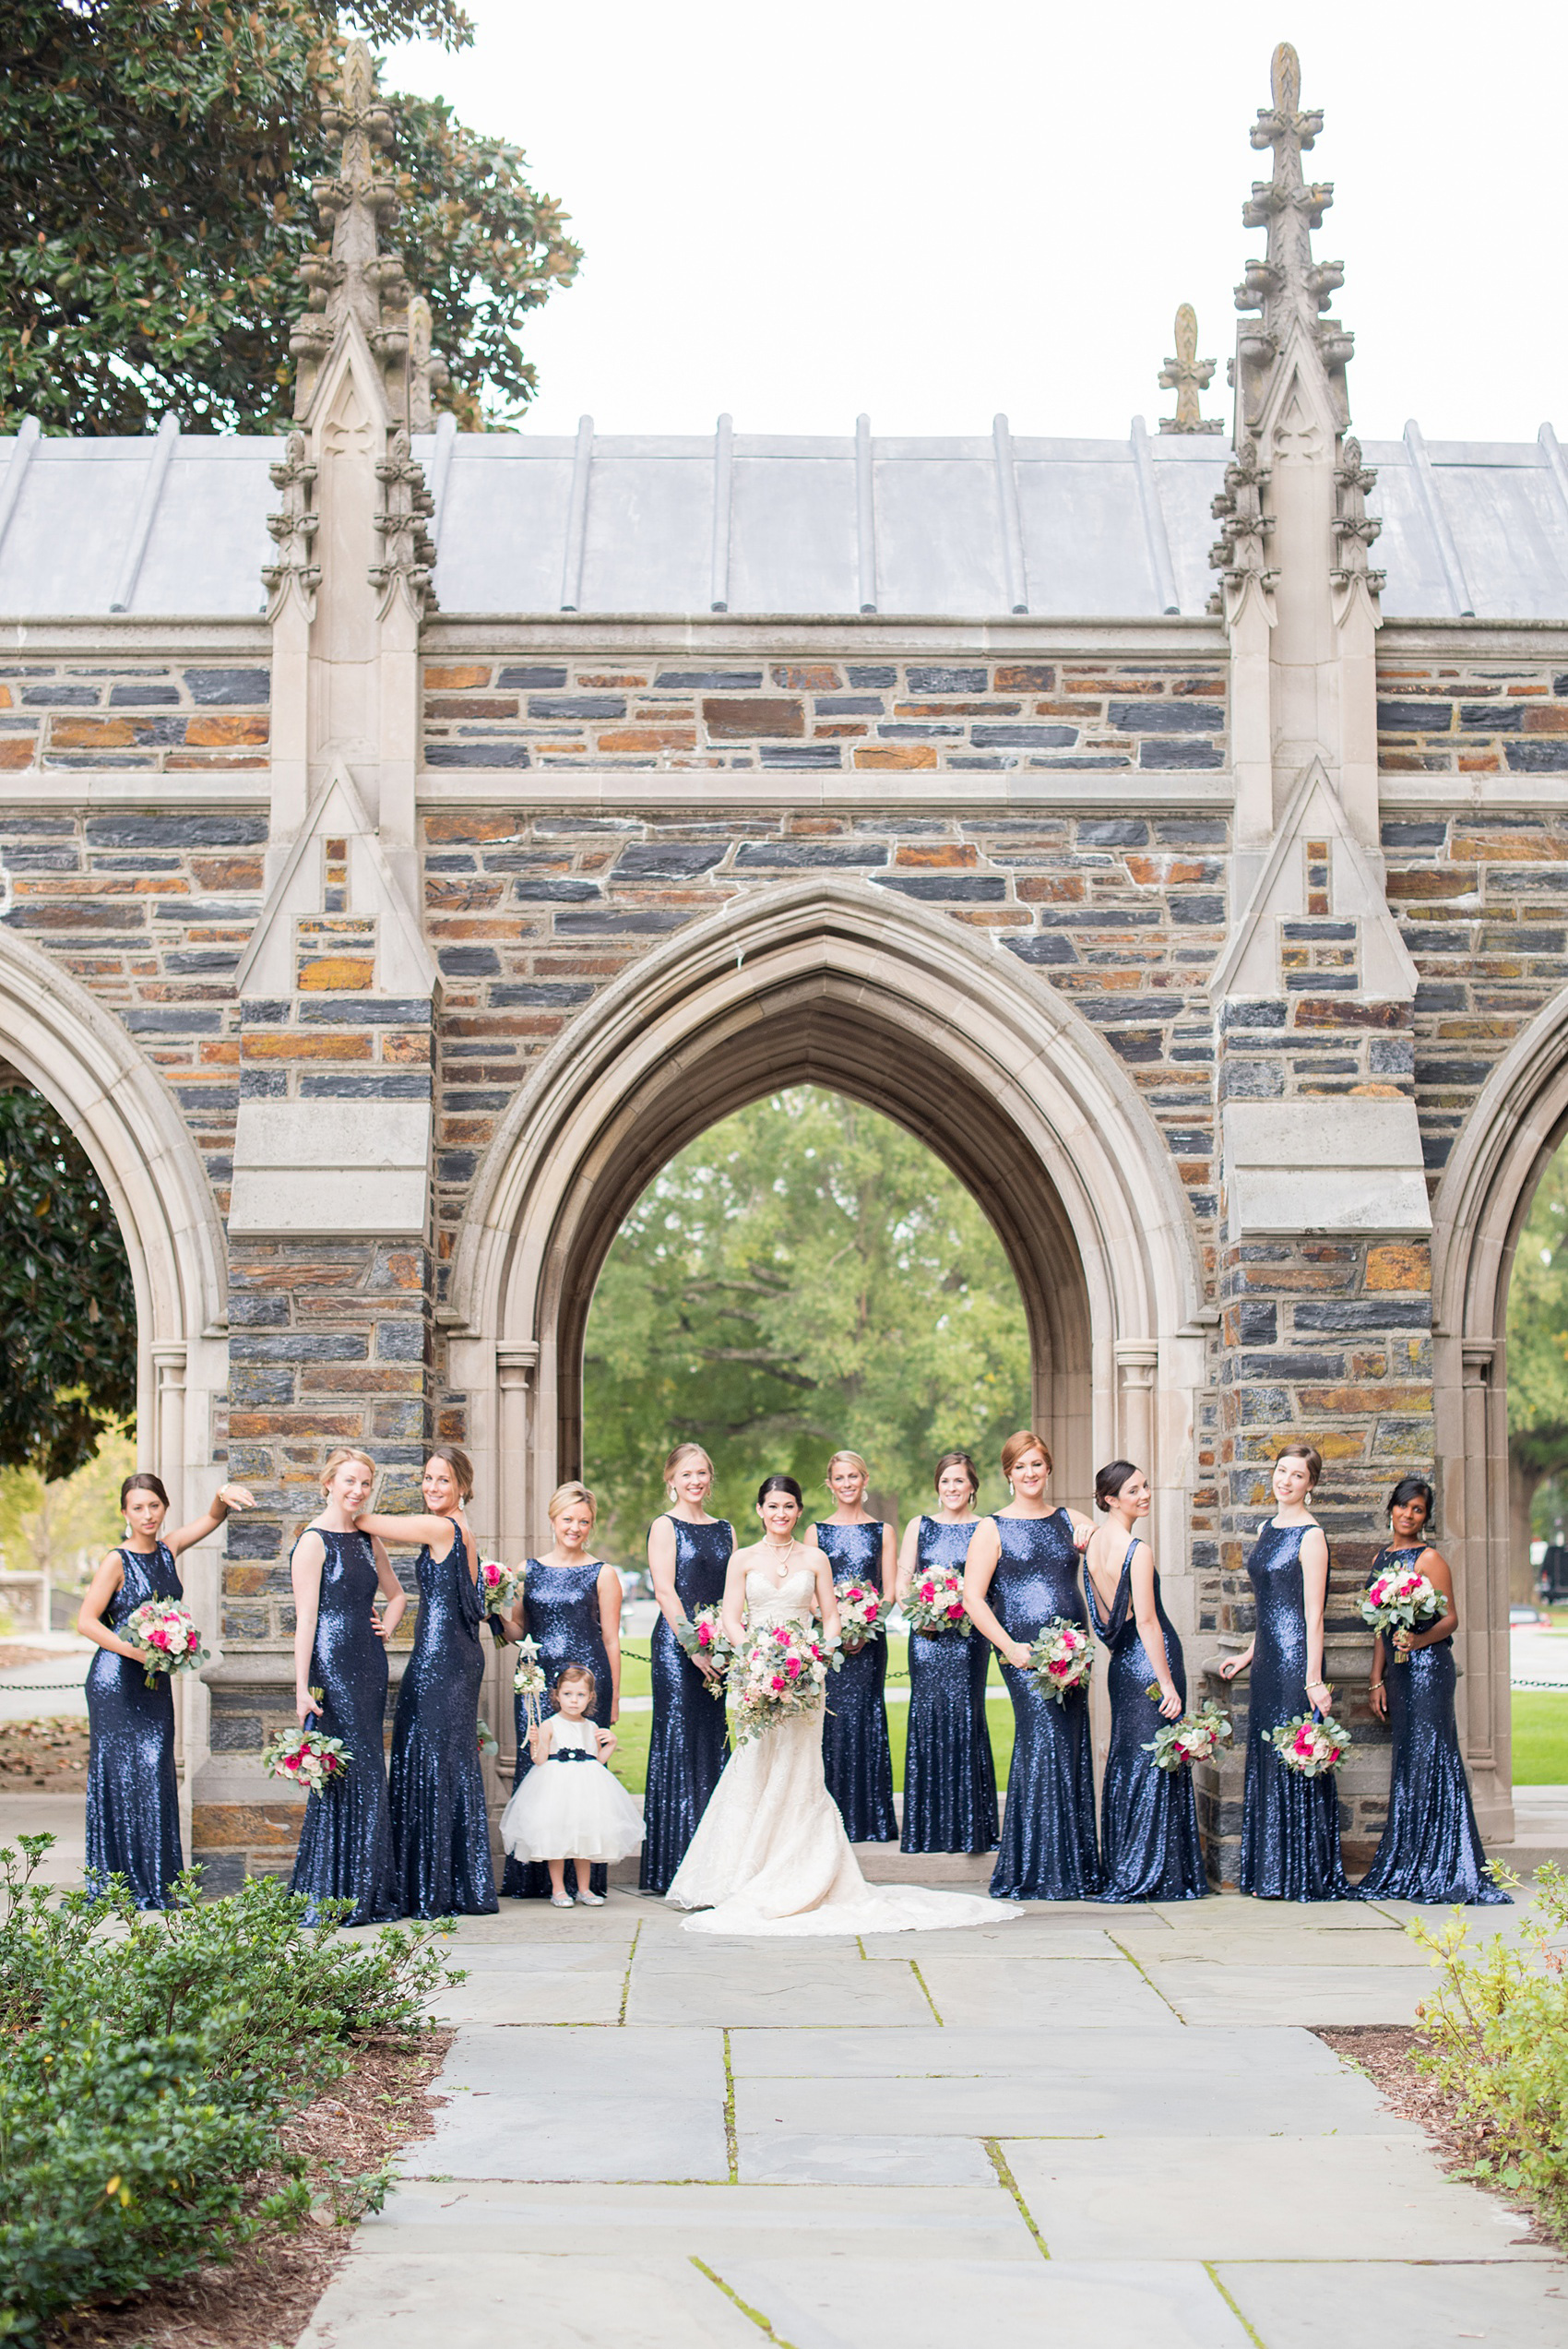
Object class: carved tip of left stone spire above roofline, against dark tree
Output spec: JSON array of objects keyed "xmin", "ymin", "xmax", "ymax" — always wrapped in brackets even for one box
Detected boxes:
[{"xmin": 289, "ymin": 40, "xmax": 446, "ymax": 432}]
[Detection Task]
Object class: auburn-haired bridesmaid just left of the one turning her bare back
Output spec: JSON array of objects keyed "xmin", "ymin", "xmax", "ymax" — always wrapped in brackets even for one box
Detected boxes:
[{"xmin": 965, "ymin": 1433, "xmax": 1099, "ymax": 1901}]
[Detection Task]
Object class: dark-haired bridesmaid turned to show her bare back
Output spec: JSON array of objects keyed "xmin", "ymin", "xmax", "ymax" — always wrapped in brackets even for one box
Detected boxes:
[{"xmin": 1085, "ymin": 1461, "xmax": 1209, "ymax": 1901}]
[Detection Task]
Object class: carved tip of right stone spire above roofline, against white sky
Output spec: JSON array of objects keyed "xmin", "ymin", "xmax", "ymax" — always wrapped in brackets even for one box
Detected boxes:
[{"xmin": 1235, "ymin": 40, "xmax": 1354, "ymax": 430}]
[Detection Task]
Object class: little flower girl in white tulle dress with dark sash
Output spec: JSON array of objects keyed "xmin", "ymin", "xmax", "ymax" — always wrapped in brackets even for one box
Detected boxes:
[{"xmin": 500, "ymin": 1663, "xmax": 643, "ymax": 1907}]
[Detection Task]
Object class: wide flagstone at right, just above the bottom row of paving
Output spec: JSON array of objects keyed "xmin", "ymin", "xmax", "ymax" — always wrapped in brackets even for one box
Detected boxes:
[{"xmin": 1004, "ymin": 2141, "xmax": 1551, "ymax": 2260}]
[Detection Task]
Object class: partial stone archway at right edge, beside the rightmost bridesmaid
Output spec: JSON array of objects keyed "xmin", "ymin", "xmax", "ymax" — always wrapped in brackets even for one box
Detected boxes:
[{"xmin": 1431, "ymin": 991, "xmax": 1568, "ymax": 1842}]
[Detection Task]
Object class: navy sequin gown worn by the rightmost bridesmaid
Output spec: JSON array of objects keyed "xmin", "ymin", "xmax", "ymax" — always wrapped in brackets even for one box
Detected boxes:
[{"xmin": 1357, "ymin": 1541, "xmax": 1509, "ymax": 1907}]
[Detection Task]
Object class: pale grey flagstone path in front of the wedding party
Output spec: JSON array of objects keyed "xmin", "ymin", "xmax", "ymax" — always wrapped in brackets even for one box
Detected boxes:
[{"xmin": 301, "ymin": 1893, "xmax": 1568, "ymax": 2349}]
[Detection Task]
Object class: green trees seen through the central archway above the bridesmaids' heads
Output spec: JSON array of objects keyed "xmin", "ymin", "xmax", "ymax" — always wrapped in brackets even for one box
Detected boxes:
[{"xmin": 585, "ymin": 1085, "xmax": 1030, "ymax": 1562}]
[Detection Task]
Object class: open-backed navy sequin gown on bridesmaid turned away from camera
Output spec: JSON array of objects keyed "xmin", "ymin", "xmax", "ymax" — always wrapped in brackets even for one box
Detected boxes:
[{"xmin": 1085, "ymin": 1536, "xmax": 1209, "ymax": 1901}]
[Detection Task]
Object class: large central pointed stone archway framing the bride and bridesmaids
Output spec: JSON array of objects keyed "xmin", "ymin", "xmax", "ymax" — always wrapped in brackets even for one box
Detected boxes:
[{"xmin": 448, "ymin": 881, "xmax": 1205, "ymax": 1604}]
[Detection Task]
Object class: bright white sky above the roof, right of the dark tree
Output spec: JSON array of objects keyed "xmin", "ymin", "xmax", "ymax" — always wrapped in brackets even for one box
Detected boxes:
[{"xmin": 383, "ymin": 0, "xmax": 1568, "ymax": 439}]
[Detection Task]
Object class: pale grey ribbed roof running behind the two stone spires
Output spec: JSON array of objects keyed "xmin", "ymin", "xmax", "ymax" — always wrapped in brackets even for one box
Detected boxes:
[{"xmin": 0, "ymin": 418, "xmax": 1568, "ymax": 620}]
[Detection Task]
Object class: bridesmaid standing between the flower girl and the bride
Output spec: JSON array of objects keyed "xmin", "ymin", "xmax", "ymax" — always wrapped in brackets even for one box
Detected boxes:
[{"xmin": 638, "ymin": 1445, "xmax": 735, "ymax": 1893}]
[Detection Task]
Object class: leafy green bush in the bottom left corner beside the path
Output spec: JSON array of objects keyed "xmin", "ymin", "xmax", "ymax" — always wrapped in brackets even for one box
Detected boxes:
[{"xmin": 0, "ymin": 1834, "xmax": 460, "ymax": 2340}]
